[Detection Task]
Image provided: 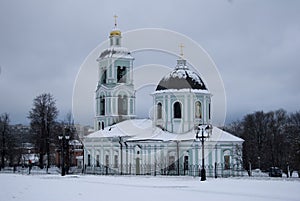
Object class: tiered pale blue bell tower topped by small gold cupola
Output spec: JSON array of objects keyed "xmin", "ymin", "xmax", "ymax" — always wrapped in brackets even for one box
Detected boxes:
[{"xmin": 94, "ymin": 15, "xmax": 135, "ymax": 130}]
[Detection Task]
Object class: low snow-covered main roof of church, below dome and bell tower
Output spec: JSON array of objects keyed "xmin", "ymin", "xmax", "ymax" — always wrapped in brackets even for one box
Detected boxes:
[{"xmin": 86, "ymin": 119, "xmax": 244, "ymax": 142}]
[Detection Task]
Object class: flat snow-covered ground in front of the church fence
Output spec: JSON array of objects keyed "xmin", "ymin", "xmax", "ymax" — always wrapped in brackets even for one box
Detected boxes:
[{"xmin": 0, "ymin": 173, "xmax": 300, "ymax": 201}]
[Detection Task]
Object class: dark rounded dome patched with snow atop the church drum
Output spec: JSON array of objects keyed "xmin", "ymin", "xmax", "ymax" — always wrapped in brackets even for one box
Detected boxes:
[{"xmin": 156, "ymin": 68, "xmax": 207, "ymax": 91}]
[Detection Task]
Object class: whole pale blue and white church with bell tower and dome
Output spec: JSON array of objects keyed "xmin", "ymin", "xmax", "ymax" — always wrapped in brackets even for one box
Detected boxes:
[{"xmin": 83, "ymin": 21, "xmax": 243, "ymax": 176}]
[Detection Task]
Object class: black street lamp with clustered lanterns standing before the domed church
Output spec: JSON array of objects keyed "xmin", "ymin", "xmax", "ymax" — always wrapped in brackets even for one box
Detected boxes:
[{"xmin": 194, "ymin": 125, "xmax": 212, "ymax": 181}]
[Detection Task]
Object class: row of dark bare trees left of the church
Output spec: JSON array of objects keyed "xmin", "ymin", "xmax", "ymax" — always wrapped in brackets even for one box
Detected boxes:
[{"xmin": 0, "ymin": 93, "xmax": 78, "ymax": 170}]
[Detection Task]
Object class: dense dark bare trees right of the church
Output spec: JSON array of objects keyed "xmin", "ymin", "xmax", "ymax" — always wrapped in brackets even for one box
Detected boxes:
[{"xmin": 225, "ymin": 109, "xmax": 300, "ymax": 175}]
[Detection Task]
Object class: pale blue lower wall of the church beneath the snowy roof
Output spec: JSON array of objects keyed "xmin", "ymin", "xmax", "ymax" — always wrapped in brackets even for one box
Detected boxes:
[{"xmin": 85, "ymin": 138, "xmax": 241, "ymax": 176}]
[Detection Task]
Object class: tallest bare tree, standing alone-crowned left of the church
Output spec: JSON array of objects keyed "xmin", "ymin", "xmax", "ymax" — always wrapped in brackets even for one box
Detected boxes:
[{"xmin": 28, "ymin": 93, "xmax": 58, "ymax": 170}]
